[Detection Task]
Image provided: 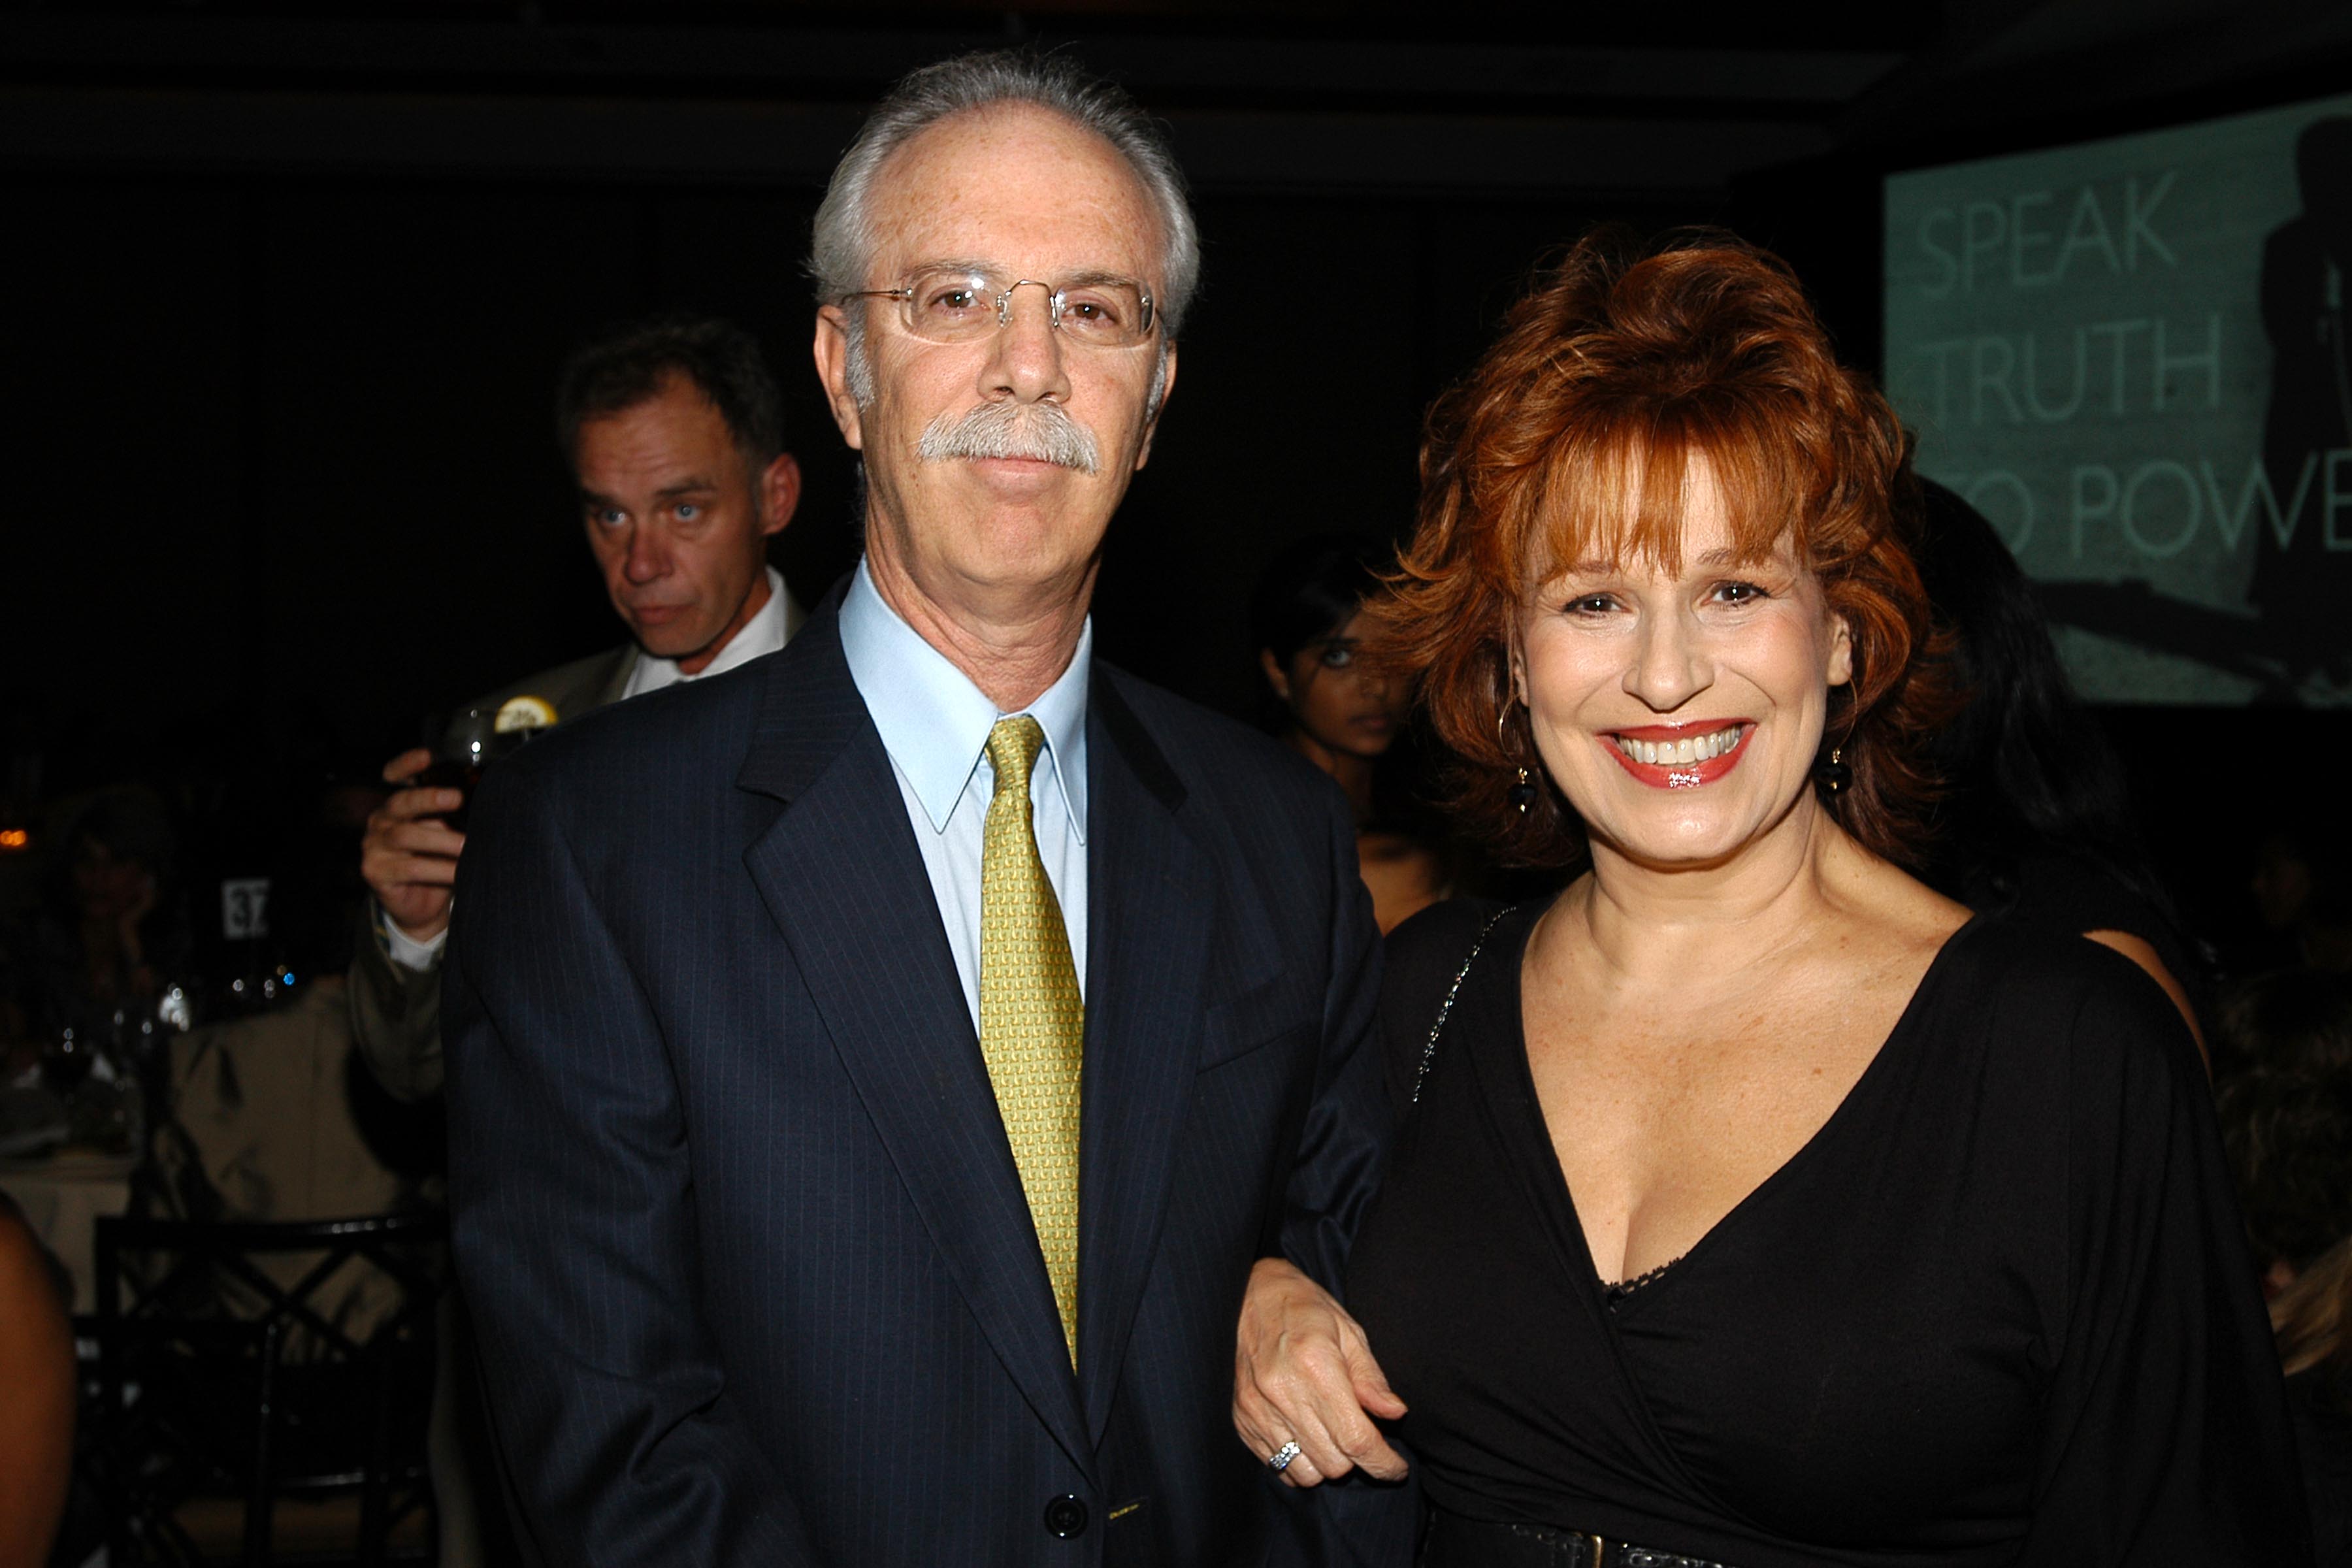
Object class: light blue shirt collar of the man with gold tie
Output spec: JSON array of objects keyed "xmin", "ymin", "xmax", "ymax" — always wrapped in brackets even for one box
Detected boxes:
[{"xmin": 840, "ymin": 559, "xmax": 1094, "ymax": 844}]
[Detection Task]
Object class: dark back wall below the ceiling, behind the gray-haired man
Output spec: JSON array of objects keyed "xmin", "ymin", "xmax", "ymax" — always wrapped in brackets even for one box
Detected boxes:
[{"xmin": 0, "ymin": 174, "xmax": 1712, "ymax": 771}]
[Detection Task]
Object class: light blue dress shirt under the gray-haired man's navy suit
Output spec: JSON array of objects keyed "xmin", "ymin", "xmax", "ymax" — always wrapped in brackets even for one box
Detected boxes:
[{"xmin": 842, "ymin": 559, "xmax": 1094, "ymax": 1032}]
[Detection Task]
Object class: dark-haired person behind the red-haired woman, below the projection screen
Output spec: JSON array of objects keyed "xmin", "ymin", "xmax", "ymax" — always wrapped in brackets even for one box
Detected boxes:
[{"xmin": 1919, "ymin": 482, "xmax": 2206, "ymax": 1049}]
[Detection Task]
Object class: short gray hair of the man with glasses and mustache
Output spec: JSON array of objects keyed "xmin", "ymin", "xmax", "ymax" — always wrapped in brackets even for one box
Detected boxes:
[{"xmin": 809, "ymin": 50, "xmax": 1200, "ymax": 409}]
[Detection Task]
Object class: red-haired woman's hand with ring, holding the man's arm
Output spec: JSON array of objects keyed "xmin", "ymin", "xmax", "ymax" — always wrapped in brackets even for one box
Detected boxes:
[{"xmin": 1232, "ymin": 1258, "xmax": 1407, "ymax": 1486}]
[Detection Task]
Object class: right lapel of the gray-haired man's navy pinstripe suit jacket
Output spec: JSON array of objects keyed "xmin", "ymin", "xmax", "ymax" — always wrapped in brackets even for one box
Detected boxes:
[{"xmin": 1077, "ymin": 681, "xmax": 1216, "ymax": 1439}]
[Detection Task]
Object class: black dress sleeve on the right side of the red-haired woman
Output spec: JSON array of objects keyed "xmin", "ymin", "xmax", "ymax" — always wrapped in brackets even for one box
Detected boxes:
[{"xmin": 2018, "ymin": 950, "xmax": 2310, "ymax": 1568}]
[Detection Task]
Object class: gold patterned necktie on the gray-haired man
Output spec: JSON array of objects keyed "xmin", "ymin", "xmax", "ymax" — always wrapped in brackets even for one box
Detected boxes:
[{"xmin": 981, "ymin": 715, "xmax": 1086, "ymax": 1366}]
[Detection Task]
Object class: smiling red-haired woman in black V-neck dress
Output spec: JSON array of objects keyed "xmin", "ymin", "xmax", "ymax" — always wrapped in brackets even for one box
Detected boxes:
[{"xmin": 1235, "ymin": 233, "xmax": 2308, "ymax": 1568}]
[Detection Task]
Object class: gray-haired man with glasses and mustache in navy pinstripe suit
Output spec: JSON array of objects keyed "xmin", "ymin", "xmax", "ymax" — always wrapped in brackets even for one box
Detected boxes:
[{"xmin": 444, "ymin": 56, "xmax": 1409, "ymax": 1568}]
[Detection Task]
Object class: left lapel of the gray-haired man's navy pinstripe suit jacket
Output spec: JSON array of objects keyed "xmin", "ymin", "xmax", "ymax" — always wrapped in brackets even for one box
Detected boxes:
[{"xmin": 736, "ymin": 606, "xmax": 1094, "ymax": 1471}]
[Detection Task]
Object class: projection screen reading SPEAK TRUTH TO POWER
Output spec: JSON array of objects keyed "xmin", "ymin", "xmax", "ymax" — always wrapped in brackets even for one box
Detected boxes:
[{"xmin": 1886, "ymin": 97, "xmax": 2352, "ymax": 708}]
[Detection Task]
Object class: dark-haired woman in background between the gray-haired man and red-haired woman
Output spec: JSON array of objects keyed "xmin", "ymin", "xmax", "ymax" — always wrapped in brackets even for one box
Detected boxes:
[{"xmin": 1249, "ymin": 536, "xmax": 1449, "ymax": 931}]
